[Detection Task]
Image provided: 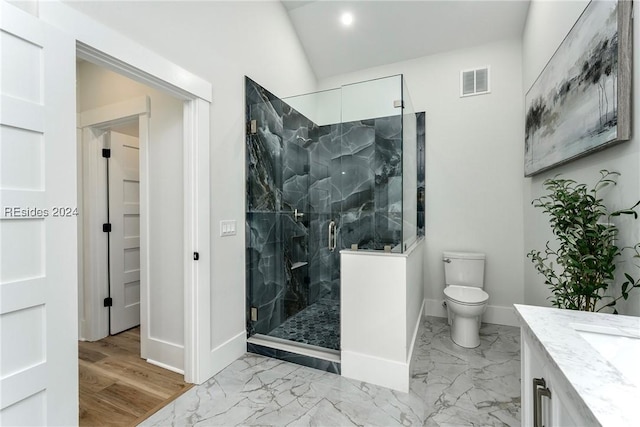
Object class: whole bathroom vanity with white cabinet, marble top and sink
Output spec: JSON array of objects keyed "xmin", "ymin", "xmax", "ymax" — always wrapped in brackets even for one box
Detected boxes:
[{"xmin": 515, "ymin": 304, "xmax": 640, "ymax": 427}]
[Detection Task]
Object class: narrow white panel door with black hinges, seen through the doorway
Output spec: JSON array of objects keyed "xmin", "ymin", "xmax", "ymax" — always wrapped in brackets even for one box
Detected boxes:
[{"xmin": 108, "ymin": 131, "xmax": 140, "ymax": 334}]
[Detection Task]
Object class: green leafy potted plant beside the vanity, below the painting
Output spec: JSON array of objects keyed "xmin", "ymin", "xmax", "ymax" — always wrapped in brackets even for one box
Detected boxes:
[{"xmin": 527, "ymin": 170, "xmax": 640, "ymax": 314}]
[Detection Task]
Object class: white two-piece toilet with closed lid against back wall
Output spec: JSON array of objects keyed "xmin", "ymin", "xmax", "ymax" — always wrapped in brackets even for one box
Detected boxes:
[{"xmin": 442, "ymin": 252, "xmax": 489, "ymax": 348}]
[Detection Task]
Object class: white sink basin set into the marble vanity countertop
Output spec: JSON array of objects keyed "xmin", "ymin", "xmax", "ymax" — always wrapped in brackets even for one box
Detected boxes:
[{"xmin": 571, "ymin": 323, "xmax": 640, "ymax": 388}]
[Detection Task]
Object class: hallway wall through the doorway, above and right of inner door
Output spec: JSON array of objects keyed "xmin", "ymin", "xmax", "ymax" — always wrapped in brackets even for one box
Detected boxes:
[{"xmin": 77, "ymin": 62, "xmax": 184, "ymax": 369}]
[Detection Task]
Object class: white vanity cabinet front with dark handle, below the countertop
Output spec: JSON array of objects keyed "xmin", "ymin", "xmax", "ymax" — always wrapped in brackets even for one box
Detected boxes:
[{"xmin": 520, "ymin": 330, "xmax": 588, "ymax": 427}]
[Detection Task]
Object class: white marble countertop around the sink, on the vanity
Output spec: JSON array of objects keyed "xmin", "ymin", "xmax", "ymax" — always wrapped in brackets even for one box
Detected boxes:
[{"xmin": 514, "ymin": 304, "xmax": 640, "ymax": 427}]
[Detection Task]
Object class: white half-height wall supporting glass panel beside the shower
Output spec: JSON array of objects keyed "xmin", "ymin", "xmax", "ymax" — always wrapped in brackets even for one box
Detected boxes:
[{"xmin": 340, "ymin": 239, "xmax": 425, "ymax": 393}]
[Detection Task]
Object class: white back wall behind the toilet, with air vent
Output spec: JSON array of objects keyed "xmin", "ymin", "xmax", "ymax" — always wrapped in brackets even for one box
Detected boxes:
[{"xmin": 320, "ymin": 40, "xmax": 525, "ymax": 323}]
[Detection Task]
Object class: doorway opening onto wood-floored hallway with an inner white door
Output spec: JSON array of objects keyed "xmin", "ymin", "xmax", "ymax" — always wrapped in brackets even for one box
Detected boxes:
[{"xmin": 77, "ymin": 61, "xmax": 187, "ymax": 424}]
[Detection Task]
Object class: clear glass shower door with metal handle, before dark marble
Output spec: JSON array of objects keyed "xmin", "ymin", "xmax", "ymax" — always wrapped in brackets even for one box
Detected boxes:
[{"xmin": 246, "ymin": 79, "xmax": 340, "ymax": 350}]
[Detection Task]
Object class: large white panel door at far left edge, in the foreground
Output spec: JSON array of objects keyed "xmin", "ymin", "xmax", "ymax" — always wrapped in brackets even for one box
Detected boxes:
[{"xmin": 0, "ymin": 1, "xmax": 78, "ymax": 426}]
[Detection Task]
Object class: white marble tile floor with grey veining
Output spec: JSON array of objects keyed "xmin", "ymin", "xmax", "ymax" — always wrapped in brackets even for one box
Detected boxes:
[{"xmin": 141, "ymin": 317, "xmax": 520, "ymax": 427}]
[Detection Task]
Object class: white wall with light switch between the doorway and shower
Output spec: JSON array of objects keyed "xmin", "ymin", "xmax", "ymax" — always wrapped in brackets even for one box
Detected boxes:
[{"xmin": 63, "ymin": 1, "xmax": 316, "ymax": 358}]
